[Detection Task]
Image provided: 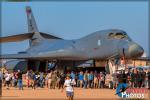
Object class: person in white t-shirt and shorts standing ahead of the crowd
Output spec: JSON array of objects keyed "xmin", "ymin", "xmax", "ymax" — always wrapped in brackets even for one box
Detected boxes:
[{"xmin": 62, "ymin": 76, "xmax": 74, "ymax": 100}]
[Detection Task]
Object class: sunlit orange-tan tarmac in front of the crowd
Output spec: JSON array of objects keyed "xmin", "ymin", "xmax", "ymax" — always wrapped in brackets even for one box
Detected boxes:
[{"xmin": 0, "ymin": 87, "xmax": 150, "ymax": 100}]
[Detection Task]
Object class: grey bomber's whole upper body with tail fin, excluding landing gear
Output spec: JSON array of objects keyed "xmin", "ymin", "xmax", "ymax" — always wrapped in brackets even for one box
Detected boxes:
[{"xmin": 0, "ymin": 7, "xmax": 144, "ymax": 60}]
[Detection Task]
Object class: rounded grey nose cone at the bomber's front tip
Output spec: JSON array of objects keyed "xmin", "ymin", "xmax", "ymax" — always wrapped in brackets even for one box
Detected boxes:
[{"xmin": 128, "ymin": 44, "xmax": 144, "ymax": 57}]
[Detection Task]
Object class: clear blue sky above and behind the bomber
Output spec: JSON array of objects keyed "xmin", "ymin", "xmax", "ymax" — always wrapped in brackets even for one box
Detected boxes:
[{"xmin": 1, "ymin": 1, "xmax": 148, "ymax": 54}]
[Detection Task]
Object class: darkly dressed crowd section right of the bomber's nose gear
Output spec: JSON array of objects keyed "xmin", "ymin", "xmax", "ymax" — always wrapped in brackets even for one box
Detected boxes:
[{"xmin": 112, "ymin": 68, "xmax": 150, "ymax": 89}]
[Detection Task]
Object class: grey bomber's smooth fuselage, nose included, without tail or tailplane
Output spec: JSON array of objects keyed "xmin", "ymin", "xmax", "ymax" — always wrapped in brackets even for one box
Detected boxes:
[{"xmin": 27, "ymin": 30, "xmax": 143, "ymax": 60}]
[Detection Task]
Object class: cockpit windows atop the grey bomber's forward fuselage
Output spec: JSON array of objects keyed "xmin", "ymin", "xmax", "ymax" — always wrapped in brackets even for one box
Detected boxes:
[{"xmin": 108, "ymin": 32, "xmax": 128, "ymax": 39}]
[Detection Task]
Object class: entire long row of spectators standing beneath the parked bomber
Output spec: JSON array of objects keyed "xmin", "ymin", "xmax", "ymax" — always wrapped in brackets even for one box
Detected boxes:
[{"xmin": 0, "ymin": 69, "xmax": 150, "ymax": 90}]
